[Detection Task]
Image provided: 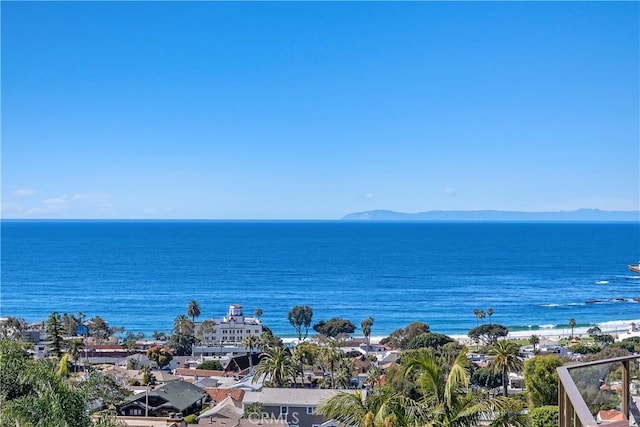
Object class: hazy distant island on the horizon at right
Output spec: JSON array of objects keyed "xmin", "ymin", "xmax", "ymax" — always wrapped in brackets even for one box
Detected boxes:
[{"xmin": 342, "ymin": 209, "xmax": 640, "ymax": 222}]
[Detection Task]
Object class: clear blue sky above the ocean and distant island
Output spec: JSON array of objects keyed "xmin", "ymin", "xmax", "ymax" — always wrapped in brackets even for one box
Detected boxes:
[{"xmin": 1, "ymin": 1, "xmax": 640, "ymax": 219}]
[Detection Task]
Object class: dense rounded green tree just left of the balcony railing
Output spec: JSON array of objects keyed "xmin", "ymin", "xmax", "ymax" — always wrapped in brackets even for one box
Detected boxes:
[{"xmin": 524, "ymin": 354, "xmax": 562, "ymax": 408}]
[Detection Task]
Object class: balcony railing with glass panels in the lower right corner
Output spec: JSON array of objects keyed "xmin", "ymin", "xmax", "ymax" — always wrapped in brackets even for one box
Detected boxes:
[{"xmin": 557, "ymin": 354, "xmax": 640, "ymax": 427}]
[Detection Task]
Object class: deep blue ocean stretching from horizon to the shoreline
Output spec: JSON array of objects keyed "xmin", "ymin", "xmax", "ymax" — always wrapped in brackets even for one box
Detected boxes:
[{"xmin": 0, "ymin": 220, "xmax": 640, "ymax": 337}]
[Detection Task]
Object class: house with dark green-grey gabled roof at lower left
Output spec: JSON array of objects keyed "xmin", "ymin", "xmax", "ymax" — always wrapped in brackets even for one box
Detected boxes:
[{"xmin": 118, "ymin": 381, "xmax": 209, "ymax": 417}]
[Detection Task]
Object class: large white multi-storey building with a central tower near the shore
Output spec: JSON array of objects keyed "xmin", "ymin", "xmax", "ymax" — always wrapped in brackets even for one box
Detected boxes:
[{"xmin": 194, "ymin": 304, "xmax": 262, "ymax": 356}]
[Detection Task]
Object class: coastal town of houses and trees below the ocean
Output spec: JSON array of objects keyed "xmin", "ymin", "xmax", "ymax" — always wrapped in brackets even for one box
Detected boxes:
[{"xmin": 0, "ymin": 300, "xmax": 640, "ymax": 427}]
